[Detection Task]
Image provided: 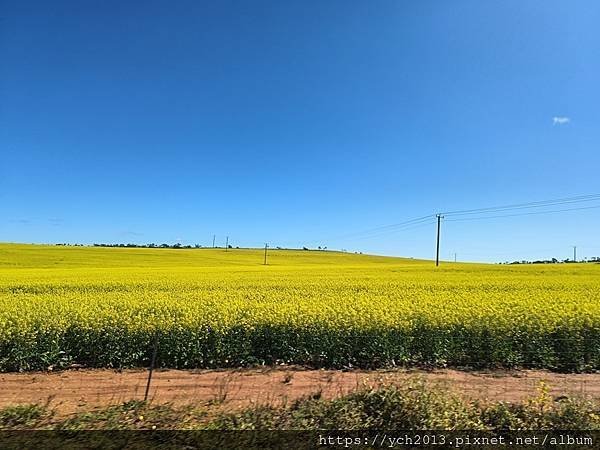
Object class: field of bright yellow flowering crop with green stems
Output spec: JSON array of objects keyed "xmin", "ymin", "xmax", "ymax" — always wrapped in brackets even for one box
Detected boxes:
[{"xmin": 0, "ymin": 244, "xmax": 600, "ymax": 371}]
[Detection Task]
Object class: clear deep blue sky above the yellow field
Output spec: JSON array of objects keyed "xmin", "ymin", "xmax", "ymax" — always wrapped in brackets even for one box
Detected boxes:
[{"xmin": 0, "ymin": 0, "xmax": 600, "ymax": 261}]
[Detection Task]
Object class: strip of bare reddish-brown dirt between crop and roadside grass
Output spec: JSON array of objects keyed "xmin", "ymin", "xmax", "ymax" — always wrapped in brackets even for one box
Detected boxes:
[{"xmin": 0, "ymin": 367, "xmax": 600, "ymax": 414}]
